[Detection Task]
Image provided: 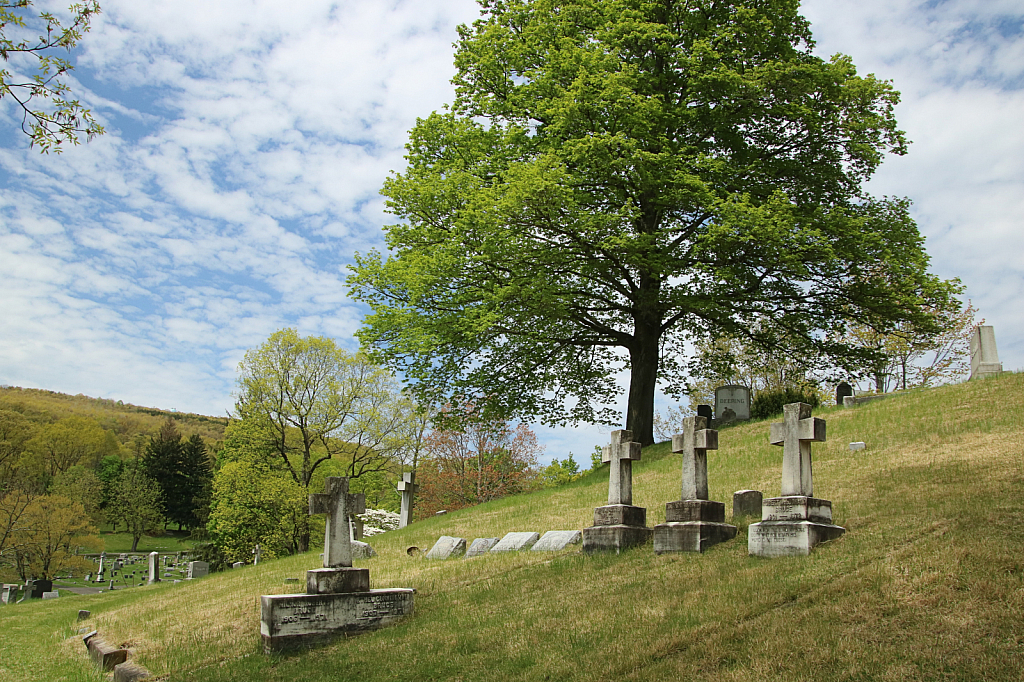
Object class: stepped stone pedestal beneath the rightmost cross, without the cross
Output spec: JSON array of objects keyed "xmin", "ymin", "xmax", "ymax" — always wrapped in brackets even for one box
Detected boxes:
[{"xmin": 746, "ymin": 496, "xmax": 846, "ymax": 557}]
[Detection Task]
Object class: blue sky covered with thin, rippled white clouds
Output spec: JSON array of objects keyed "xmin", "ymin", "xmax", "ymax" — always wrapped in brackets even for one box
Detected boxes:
[{"xmin": 0, "ymin": 0, "xmax": 1024, "ymax": 464}]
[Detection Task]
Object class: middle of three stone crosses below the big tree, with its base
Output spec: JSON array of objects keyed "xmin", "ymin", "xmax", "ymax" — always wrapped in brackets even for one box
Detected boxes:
[{"xmin": 654, "ymin": 417, "xmax": 736, "ymax": 554}]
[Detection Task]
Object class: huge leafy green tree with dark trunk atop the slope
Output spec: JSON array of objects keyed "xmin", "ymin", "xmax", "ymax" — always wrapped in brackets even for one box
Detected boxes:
[{"xmin": 349, "ymin": 0, "xmax": 945, "ymax": 443}]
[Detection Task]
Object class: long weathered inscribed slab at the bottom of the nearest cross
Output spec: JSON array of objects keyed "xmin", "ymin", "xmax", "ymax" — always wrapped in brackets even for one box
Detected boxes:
[{"xmin": 260, "ymin": 588, "xmax": 416, "ymax": 653}]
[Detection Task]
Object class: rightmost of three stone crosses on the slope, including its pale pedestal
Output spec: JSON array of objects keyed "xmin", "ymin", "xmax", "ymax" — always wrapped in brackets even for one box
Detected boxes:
[{"xmin": 746, "ymin": 402, "xmax": 846, "ymax": 557}]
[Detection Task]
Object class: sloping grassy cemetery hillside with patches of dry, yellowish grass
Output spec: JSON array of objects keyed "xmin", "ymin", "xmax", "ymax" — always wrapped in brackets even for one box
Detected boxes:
[{"xmin": 0, "ymin": 374, "xmax": 1024, "ymax": 682}]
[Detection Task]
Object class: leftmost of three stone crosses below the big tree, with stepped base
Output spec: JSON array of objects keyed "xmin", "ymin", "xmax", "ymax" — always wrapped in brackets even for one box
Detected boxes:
[{"xmin": 583, "ymin": 431, "xmax": 651, "ymax": 554}]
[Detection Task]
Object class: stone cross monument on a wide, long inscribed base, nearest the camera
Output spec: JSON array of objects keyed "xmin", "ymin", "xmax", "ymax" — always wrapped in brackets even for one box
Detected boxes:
[{"xmin": 260, "ymin": 476, "xmax": 416, "ymax": 653}]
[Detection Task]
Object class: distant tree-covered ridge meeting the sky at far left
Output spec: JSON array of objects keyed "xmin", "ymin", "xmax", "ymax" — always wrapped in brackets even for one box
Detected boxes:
[{"xmin": 0, "ymin": 386, "xmax": 228, "ymax": 449}]
